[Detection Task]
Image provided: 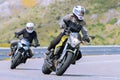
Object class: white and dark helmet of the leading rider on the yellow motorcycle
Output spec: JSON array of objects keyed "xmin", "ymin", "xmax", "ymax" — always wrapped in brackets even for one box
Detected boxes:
[{"xmin": 73, "ymin": 6, "xmax": 85, "ymax": 20}]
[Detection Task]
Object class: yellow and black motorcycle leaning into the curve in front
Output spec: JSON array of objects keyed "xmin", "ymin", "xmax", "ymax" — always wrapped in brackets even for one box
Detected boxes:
[{"xmin": 42, "ymin": 29, "xmax": 82, "ymax": 76}]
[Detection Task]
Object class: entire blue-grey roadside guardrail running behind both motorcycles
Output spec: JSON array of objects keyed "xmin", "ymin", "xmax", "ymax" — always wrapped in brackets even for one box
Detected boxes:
[{"xmin": 0, "ymin": 45, "xmax": 120, "ymax": 58}]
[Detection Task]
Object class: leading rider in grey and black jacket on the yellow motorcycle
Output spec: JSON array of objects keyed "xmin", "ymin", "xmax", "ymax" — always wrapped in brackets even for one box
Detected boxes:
[{"xmin": 46, "ymin": 6, "xmax": 90, "ymax": 63}]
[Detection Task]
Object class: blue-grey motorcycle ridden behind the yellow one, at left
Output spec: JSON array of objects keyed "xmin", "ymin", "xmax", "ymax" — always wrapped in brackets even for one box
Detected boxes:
[{"xmin": 10, "ymin": 38, "xmax": 34, "ymax": 69}]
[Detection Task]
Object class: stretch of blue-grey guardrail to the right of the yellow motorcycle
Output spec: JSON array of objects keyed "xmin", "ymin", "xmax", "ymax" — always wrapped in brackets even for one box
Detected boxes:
[{"xmin": 81, "ymin": 45, "xmax": 120, "ymax": 54}]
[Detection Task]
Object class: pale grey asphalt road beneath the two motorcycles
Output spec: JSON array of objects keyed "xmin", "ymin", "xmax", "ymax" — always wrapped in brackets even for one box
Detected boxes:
[{"xmin": 0, "ymin": 55, "xmax": 120, "ymax": 80}]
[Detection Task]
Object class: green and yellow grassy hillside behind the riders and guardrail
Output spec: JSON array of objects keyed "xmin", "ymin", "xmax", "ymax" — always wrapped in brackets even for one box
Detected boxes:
[{"xmin": 0, "ymin": 0, "xmax": 120, "ymax": 46}]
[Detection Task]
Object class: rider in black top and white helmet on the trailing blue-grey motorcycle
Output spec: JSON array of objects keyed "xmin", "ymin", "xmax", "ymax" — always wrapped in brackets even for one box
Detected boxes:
[{"xmin": 8, "ymin": 22, "xmax": 40, "ymax": 58}]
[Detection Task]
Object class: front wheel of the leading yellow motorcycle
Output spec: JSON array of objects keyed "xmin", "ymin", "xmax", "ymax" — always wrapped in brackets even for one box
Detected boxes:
[{"xmin": 56, "ymin": 52, "xmax": 73, "ymax": 76}]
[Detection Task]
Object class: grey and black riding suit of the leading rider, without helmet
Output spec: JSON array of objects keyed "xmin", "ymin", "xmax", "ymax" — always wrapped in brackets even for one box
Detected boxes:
[{"xmin": 48, "ymin": 14, "xmax": 90, "ymax": 60}]
